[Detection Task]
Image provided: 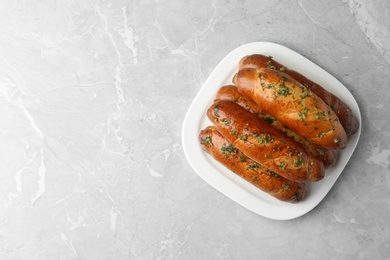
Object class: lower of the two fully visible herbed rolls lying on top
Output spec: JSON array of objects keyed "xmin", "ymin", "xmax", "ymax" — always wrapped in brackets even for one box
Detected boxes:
[{"xmin": 207, "ymin": 100, "xmax": 324, "ymax": 182}]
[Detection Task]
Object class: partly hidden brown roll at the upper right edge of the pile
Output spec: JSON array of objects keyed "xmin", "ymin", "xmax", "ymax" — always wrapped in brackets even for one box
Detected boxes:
[{"xmin": 239, "ymin": 54, "xmax": 359, "ymax": 136}]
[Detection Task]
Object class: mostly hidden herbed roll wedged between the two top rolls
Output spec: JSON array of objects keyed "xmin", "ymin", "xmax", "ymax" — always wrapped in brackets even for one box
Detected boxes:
[{"xmin": 215, "ymin": 85, "xmax": 336, "ymax": 168}]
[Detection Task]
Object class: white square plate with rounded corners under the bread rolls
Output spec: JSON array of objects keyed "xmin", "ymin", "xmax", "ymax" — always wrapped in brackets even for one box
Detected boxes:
[{"xmin": 182, "ymin": 42, "xmax": 361, "ymax": 220}]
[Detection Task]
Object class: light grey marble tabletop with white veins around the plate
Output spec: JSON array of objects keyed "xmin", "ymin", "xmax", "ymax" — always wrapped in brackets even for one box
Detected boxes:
[{"xmin": 0, "ymin": 0, "xmax": 390, "ymax": 260}]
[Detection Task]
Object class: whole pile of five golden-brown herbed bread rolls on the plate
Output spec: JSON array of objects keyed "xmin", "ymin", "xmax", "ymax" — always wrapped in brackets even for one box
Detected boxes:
[{"xmin": 198, "ymin": 54, "xmax": 359, "ymax": 203}]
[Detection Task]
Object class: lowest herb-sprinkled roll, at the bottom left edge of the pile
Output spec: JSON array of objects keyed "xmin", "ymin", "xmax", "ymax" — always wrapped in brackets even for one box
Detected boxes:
[{"xmin": 199, "ymin": 126, "xmax": 307, "ymax": 202}]
